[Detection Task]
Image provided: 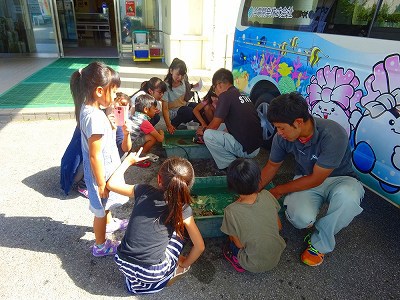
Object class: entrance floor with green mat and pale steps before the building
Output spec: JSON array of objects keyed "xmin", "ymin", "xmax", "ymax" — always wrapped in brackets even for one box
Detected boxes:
[{"xmin": 0, "ymin": 57, "xmax": 212, "ymax": 124}]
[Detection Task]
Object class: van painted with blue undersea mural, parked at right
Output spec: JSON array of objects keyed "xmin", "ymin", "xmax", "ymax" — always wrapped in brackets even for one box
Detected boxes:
[{"xmin": 232, "ymin": 0, "xmax": 400, "ymax": 207}]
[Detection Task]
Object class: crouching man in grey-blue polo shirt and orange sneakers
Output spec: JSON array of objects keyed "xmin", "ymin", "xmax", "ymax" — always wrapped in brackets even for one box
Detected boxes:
[{"xmin": 260, "ymin": 93, "xmax": 364, "ymax": 266}]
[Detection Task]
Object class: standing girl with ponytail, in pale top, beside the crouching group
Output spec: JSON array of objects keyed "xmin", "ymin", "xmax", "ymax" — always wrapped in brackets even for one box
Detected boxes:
[{"xmin": 70, "ymin": 62, "xmax": 130, "ymax": 256}]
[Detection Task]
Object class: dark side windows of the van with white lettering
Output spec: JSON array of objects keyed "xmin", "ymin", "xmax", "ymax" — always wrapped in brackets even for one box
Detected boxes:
[{"xmin": 242, "ymin": 0, "xmax": 400, "ymax": 40}]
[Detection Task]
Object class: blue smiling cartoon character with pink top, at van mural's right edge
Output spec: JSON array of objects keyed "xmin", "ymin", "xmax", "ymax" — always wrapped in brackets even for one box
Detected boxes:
[{"xmin": 350, "ymin": 54, "xmax": 400, "ymax": 194}]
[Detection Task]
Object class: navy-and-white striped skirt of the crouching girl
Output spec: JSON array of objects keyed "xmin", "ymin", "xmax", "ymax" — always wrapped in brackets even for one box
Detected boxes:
[{"xmin": 115, "ymin": 233, "xmax": 183, "ymax": 294}]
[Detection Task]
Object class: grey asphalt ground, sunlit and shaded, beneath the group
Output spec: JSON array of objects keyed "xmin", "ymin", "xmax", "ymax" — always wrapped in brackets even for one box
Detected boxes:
[{"xmin": 0, "ymin": 119, "xmax": 400, "ymax": 299}]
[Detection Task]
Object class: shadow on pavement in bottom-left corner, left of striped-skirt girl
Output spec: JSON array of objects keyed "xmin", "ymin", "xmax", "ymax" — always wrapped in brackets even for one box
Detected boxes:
[{"xmin": 0, "ymin": 214, "xmax": 127, "ymax": 296}]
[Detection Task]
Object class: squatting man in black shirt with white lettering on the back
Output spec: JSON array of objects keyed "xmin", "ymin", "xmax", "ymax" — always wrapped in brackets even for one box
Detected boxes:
[{"xmin": 203, "ymin": 68, "xmax": 262, "ymax": 170}]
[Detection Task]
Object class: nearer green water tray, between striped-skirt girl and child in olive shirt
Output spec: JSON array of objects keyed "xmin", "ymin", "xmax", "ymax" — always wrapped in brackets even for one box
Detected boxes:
[{"xmin": 191, "ymin": 176, "xmax": 273, "ymax": 238}]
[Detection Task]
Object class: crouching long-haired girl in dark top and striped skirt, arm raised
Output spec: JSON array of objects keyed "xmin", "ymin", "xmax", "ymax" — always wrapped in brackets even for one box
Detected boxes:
[{"xmin": 107, "ymin": 149, "xmax": 204, "ymax": 294}]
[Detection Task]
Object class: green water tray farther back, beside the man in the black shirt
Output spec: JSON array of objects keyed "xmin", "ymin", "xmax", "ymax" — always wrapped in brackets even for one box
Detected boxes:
[{"xmin": 162, "ymin": 130, "xmax": 212, "ymax": 159}]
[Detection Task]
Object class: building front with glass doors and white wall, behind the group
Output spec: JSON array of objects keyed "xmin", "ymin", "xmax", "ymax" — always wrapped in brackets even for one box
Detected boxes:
[{"xmin": 0, "ymin": 0, "xmax": 240, "ymax": 70}]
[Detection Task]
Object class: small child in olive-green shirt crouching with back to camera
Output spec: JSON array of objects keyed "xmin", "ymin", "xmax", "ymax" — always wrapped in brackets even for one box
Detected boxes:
[{"xmin": 221, "ymin": 158, "xmax": 286, "ymax": 272}]
